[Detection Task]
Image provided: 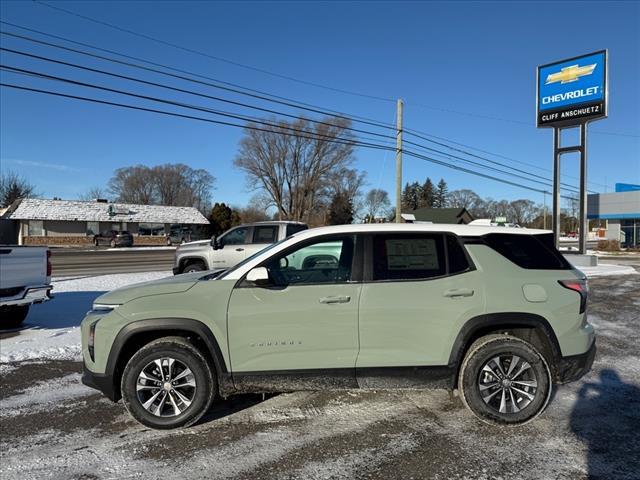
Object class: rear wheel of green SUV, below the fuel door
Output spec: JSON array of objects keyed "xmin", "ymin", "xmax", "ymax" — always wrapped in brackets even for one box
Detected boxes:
[{"xmin": 458, "ymin": 335, "xmax": 552, "ymax": 425}]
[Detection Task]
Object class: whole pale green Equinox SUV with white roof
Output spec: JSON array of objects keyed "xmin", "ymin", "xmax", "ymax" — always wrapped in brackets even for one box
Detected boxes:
[{"xmin": 82, "ymin": 224, "xmax": 595, "ymax": 428}]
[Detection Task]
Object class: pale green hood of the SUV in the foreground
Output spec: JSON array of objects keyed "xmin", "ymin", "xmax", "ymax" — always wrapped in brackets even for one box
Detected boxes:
[{"xmin": 95, "ymin": 272, "xmax": 207, "ymax": 305}]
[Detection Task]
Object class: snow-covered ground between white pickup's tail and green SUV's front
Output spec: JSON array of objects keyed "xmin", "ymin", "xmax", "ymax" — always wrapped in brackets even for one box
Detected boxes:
[{"xmin": 0, "ymin": 272, "xmax": 171, "ymax": 364}]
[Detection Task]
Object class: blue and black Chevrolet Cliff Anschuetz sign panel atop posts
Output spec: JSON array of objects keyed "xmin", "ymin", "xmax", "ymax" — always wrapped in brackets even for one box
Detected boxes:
[{"xmin": 537, "ymin": 50, "xmax": 608, "ymax": 127}]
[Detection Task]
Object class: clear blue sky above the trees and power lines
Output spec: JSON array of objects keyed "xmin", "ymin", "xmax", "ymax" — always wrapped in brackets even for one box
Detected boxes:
[{"xmin": 0, "ymin": 1, "xmax": 640, "ymax": 205}]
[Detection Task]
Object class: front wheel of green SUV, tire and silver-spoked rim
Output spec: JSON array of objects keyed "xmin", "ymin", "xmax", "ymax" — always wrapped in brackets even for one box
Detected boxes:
[{"xmin": 121, "ymin": 337, "xmax": 216, "ymax": 429}]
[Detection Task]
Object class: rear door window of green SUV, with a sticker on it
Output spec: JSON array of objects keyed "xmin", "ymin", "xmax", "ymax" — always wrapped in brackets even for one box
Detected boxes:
[{"xmin": 373, "ymin": 234, "xmax": 446, "ymax": 280}]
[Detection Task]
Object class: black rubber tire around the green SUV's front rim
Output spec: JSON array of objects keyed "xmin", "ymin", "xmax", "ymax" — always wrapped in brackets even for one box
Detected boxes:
[{"xmin": 120, "ymin": 337, "xmax": 217, "ymax": 430}]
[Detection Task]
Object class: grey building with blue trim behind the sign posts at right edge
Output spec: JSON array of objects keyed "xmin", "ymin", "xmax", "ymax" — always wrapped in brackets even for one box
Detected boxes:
[{"xmin": 587, "ymin": 183, "xmax": 640, "ymax": 248}]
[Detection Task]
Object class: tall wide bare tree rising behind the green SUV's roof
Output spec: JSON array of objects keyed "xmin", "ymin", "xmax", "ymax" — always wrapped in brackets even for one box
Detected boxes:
[{"xmin": 235, "ymin": 118, "xmax": 353, "ymax": 221}]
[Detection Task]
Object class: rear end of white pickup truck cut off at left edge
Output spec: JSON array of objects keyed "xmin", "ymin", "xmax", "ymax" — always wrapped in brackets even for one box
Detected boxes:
[{"xmin": 0, "ymin": 245, "xmax": 52, "ymax": 328}]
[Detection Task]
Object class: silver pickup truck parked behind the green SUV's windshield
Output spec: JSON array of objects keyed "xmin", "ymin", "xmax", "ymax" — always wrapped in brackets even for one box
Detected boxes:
[{"xmin": 173, "ymin": 221, "xmax": 309, "ymax": 275}]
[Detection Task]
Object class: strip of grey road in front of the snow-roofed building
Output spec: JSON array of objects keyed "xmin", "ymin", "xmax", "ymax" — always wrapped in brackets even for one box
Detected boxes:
[{"xmin": 51, "ymin": 247, "xmax": 175, "ymax": 277}]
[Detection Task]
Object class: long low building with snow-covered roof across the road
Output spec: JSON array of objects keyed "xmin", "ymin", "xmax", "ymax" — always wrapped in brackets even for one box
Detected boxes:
[{"xmin": 2, "ymin": 198, "xmax": 209, "ymax": 245}]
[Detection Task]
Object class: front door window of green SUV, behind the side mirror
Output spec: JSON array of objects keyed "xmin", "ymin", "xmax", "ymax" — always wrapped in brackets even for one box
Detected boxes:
[{"xmin": 264, "ymin": 236, "xmax": 354, "ymax": 286}]
